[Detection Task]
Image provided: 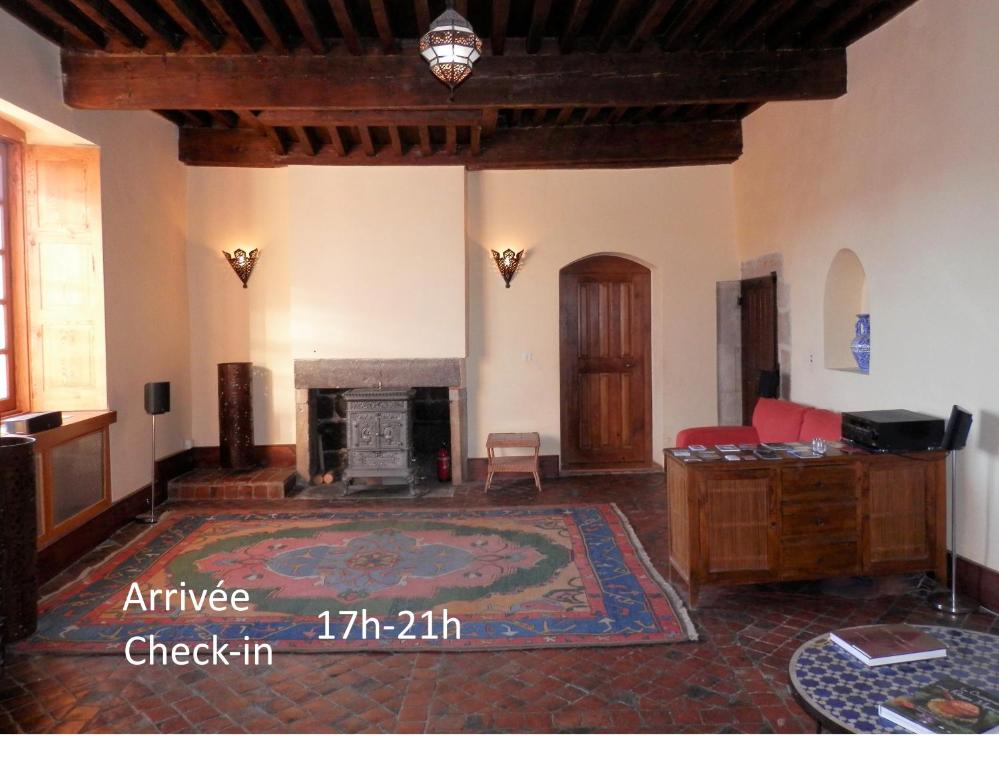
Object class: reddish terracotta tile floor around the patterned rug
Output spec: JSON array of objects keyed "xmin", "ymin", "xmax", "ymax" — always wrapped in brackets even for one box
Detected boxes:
[{"xmin": 0, "ymin": 474, "xmax": 999, "ymax": 733}]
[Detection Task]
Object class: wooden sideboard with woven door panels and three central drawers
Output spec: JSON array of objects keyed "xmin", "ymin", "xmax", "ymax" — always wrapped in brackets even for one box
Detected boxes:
[{"xmin": 664, "ymin": 447, "xmax": 947, "ymax": 605}]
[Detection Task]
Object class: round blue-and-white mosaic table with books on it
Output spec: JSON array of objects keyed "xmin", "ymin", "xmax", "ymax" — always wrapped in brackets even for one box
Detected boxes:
[{"xmin": 788, "ymin": 626, "xmax": 999, "ymax": 733}]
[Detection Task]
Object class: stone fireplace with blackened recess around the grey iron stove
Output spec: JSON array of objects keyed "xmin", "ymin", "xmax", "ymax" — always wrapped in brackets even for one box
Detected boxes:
[{"xmin": 295, "ymin": 358, "xmax": 467, "ymax": 484}]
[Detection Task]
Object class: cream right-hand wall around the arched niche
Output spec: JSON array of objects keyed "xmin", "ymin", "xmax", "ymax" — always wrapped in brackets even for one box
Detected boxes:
[{"xmin": 735, "ymin": 0, "xmax": 999, "ymax": 568}]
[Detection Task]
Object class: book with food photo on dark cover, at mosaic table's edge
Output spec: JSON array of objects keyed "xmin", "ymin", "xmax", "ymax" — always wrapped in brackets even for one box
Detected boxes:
[{"xmin": 878, "ymin": 677, "xmax": 999, "ymax": 734}]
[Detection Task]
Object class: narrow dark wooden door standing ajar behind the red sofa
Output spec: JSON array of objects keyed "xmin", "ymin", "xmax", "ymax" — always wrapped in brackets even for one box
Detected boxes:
[{"xmin": 739, "ymin": 272, "xmax": 778, "ymax": 424}]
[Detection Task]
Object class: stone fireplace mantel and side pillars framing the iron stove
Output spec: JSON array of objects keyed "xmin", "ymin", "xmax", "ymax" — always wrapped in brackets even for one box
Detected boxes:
[{"xmin": 295, "ymin": 357, "xmax": 468, "ymax": 484}]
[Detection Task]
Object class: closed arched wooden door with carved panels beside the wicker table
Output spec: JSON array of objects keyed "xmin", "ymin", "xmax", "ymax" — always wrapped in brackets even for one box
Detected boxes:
[{"xmin": 559, "ymin": 256, "xmax": 652, "ymax": 468}]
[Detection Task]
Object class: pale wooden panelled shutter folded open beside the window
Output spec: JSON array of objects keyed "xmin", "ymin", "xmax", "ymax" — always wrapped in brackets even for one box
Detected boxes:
[{"xmin": 24, "ymin": 146, "xmax": 107, "ymax": 410}]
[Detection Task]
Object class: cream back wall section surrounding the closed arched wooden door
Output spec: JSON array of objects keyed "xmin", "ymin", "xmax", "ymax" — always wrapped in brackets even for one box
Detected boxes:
[{"xmin": 466, "ymin": 166, "xmax": 738, "ymax": 461}]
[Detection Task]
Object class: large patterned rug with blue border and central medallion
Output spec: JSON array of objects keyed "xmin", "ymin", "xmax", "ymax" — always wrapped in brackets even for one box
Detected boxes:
[{"xmin": 22, "ymin": 505, "xmax": 697, "ymax": 653}]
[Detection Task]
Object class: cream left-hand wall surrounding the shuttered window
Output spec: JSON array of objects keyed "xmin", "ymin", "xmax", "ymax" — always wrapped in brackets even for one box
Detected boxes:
[{"xmin": 0, "ymin": 11, "xmax": 191, "ymax": 499}]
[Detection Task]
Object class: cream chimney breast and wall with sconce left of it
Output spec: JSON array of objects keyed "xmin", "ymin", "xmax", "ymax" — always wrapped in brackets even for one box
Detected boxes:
[{"xmin": 187, "ymin": 167, "xmax": 465, "ymax": 445}]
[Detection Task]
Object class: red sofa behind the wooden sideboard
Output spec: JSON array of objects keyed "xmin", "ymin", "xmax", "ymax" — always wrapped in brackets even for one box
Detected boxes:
[{"xmin": 676, "ymin": 397, "xmax": 842, "ymax": 448}]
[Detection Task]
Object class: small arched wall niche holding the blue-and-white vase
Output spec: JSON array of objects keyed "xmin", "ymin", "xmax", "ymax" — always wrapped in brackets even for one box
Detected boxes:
[{"xmin": 823, "ymin": 248, "xmax": 870, "ymax": 373}]
